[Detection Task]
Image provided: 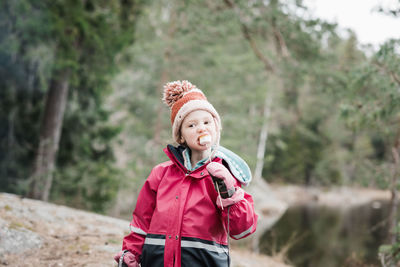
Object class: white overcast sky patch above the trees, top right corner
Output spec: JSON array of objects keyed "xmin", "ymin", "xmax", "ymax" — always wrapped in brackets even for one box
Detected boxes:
[{"xmin": 304, "ymin": 0, "xmax": 400, "ymax": 47}]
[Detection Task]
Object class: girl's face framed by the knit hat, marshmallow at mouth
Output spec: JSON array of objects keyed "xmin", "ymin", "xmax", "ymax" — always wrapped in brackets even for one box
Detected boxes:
[{"xmin": 181, "ymin": 110, "xmax": 217, "ymax": 151}]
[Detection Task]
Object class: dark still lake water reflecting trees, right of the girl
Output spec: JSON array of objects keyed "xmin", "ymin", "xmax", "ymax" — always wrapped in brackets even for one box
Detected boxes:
[{"xmin": 260, "ymin": 202, "xmax": 389, "ymax": 267}]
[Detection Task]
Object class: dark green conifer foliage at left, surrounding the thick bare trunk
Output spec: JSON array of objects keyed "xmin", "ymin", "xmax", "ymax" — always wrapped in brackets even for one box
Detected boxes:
[{"xmin": 0, "ymin": 0, "xmax": 144, "ymax": 212}]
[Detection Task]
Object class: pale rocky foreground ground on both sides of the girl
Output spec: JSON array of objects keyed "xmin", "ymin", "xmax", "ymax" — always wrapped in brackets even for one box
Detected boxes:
[{"xmin": 0, "ymin": 193, "xmax": 287, "ymax": 267}]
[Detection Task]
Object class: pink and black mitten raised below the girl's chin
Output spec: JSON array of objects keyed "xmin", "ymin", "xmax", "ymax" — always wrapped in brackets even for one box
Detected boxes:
[{"xmin": 207, "ymin": 162, "xmax": 236, "ymax": 198}]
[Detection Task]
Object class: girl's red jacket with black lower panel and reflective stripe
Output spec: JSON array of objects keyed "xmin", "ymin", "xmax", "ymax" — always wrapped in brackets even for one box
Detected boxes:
[{"xmin": 122, "ymin": 146, "xmax": 257, "ymax": 267}]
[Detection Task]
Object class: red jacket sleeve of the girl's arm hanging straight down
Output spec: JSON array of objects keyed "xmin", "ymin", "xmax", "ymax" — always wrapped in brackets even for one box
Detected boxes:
[{"xmin": 122, "ymin": 167, "xmax": 160, "ymax": 259}]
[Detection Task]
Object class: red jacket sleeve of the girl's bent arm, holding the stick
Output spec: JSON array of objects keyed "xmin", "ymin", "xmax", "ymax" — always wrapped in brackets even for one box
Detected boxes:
[{"xmin": 217, "ymin": 181, "xmax": 258, "ymax": 240}]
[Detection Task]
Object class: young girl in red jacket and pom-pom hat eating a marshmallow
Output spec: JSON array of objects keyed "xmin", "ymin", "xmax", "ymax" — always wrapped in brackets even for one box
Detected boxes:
[{"xmin": 115, "ymin": 81, "xmax": 257, "ymax": 267}]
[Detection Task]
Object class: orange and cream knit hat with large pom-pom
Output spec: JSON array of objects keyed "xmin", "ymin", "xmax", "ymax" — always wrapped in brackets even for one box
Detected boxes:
[{"xmin": 162, "ymin": 81, "xmax": 221, "ymax": 145}]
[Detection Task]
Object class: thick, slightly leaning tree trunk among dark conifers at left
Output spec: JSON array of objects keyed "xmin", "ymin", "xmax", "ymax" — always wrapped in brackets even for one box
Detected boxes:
[{"xmin": 28, "ymin": 71, "xmax": 69, "ymax": 201}]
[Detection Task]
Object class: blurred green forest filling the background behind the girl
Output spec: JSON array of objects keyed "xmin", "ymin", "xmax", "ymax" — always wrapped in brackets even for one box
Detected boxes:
[{"xmin": 0, "ymin": 0, "xmax": 400, "ymax": 266}]
